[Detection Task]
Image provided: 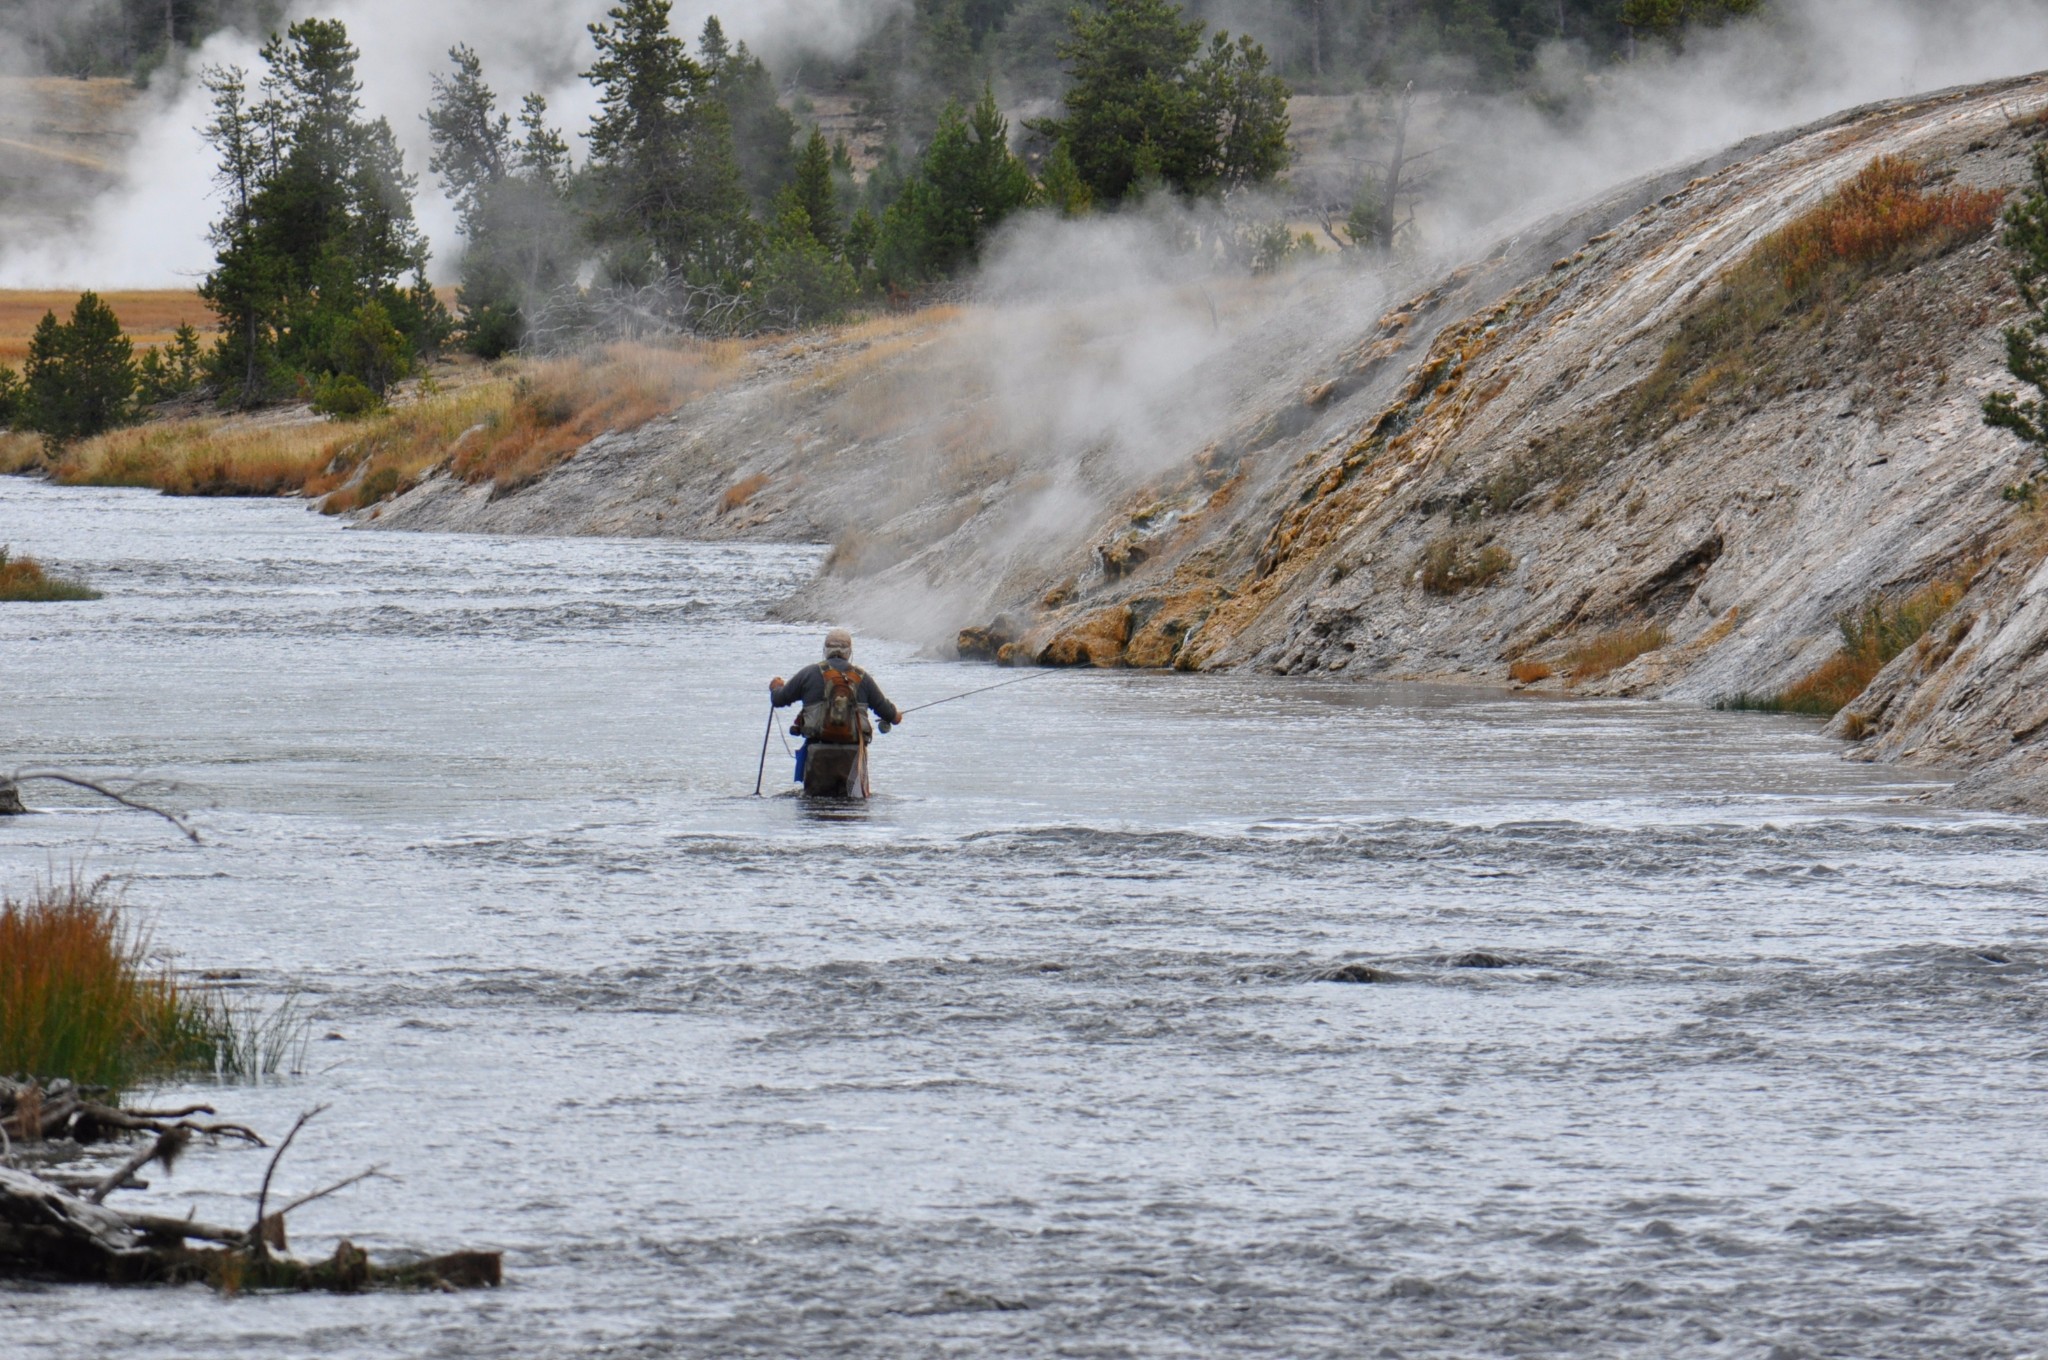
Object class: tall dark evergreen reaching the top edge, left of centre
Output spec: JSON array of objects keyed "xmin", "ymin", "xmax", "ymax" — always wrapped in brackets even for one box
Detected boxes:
[{"xmin": 584, "ymin": 0, "xmax": 752, "ymax": 281}]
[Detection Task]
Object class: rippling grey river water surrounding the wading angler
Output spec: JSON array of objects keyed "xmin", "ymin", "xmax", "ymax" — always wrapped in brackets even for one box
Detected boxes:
[{"xmin": 0, "ymin": 481, "xmax": 2048, "ymax": 1360}]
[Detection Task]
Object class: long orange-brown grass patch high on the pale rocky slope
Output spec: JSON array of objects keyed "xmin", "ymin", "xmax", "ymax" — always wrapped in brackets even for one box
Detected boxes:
[{"xmin": 1636, "ymin": 156, "xmax": 2005, "ymax": 418}]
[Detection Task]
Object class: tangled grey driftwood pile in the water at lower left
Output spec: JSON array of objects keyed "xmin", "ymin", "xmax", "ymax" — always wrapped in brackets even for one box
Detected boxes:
[{"xmin": 0, "ymin": 1079, "xmax": 504, "ymax": 1292}]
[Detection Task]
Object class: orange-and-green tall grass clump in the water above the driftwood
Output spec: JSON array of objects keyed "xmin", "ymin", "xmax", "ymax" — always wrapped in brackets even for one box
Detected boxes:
[{"xmin": 0, "ymin": 879, "xmax": 303, "ymax": 1092}]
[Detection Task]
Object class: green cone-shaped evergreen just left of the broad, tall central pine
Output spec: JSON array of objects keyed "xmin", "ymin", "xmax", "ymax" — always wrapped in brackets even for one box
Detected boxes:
[{"xmin": 874, "ymin": 88, "xmax": 1036, "ymax": 287}]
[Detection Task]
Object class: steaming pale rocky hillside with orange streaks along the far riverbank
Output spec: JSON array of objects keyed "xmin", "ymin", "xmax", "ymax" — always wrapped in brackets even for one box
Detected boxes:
[{"xmin": 383, "ymin": 78, "xmax": 2048, "ymax": 805}]
